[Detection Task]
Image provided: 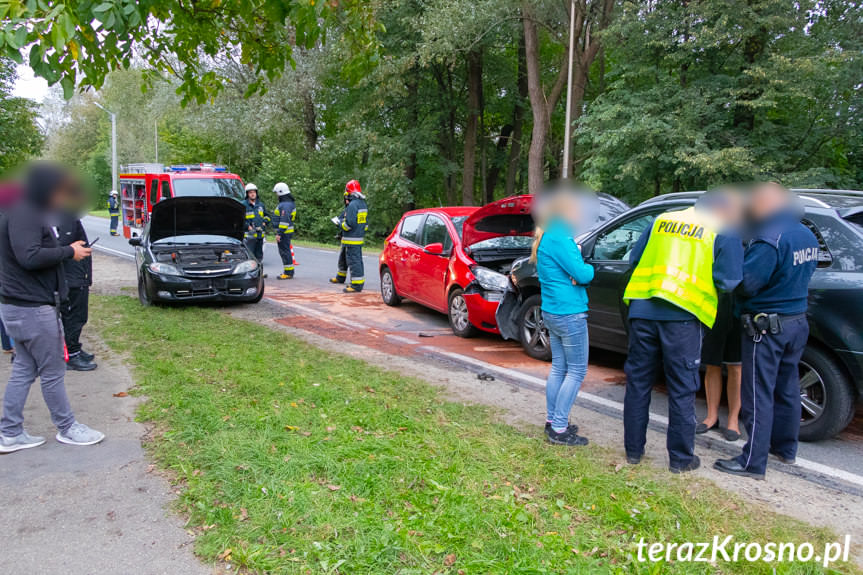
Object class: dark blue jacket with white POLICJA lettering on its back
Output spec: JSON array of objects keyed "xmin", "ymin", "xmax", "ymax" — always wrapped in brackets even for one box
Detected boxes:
[{"xmin": 739, "ymin": 212, "xmax": 818, "ymax": 315}]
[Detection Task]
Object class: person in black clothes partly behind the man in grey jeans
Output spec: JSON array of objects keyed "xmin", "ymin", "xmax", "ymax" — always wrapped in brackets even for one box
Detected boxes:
[{"xmin": 59, "ymin": 214, "xmax": 97, "ymax": 371}]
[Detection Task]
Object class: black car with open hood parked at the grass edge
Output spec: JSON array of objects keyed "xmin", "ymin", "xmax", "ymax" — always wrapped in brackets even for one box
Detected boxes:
[{"xmin": 129, "ymin": 196, "xmax": 264, "ymax": 305}]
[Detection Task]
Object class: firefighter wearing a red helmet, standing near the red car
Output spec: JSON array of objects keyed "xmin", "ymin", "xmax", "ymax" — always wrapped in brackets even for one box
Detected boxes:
[{"xmin": 330, "ymin": 180, "xmax": 369, "ymax": 293}]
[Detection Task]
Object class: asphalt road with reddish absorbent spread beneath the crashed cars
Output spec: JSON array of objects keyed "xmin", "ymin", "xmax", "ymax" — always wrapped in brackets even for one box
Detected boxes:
[{"xmin": 84, "ymin": 216, "xmax": 863, "ymax": 493}]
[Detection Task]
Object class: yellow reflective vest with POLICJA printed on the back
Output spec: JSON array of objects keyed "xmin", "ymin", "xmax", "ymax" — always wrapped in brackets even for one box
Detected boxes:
[{"xmin": 623, "ymin": 207, "xmax": 717, "ymax": 327}]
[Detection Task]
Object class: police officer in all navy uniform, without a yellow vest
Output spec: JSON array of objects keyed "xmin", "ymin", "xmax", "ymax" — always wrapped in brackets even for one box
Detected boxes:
[{"xmin": 713, "ymin": 184, "xmax": 818, "ymax": 479}]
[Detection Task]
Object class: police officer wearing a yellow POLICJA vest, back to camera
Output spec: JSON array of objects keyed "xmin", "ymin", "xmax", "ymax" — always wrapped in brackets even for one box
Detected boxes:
[{"xmin": 623, "ymin": 191, "xmax": 743, "ymax": 473}]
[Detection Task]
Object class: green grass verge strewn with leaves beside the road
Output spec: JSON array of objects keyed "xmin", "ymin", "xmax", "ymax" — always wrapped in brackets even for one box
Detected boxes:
[{"xmin": 93, "ymin": 297, "xmax": 853, "ymax": 574}]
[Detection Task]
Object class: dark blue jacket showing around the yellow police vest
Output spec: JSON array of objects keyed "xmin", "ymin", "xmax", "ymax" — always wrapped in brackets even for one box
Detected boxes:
[{"xmin": 629, "ymin": 228, "xmax": 743, "ymax": 321}]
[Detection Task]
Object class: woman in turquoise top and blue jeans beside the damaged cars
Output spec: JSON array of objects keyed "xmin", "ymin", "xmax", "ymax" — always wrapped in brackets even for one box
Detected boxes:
[{"xmin": 533, "ymin": 194, "xmax": 593, "ymax": 445}]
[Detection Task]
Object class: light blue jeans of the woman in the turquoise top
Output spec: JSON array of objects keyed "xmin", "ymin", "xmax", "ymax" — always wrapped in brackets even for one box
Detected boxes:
[{"xmin": 542, "ymin": 311, "xmax": 589, "ymax": 429}]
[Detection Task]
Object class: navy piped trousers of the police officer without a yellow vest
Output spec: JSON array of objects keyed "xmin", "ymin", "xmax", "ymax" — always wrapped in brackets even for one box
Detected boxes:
[{"xmin": 737, "ymin": 314, "xmax": 809, "ymax": 473}]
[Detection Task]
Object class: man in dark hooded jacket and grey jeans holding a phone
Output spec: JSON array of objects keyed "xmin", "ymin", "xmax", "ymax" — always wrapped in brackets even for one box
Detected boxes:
[{"xmin": 0, "ymin": 164, "xmax": 105, "ymax": 453}]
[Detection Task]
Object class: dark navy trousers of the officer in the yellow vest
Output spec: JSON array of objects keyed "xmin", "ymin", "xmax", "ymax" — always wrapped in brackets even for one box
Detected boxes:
[{"xmin": 623, "ymin": 319, "xmax": 701, "ymax": 467}]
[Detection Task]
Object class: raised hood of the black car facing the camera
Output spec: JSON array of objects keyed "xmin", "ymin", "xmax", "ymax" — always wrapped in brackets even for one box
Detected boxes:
[{"xmin": 150, "ymin": 196, "xmax": 246, "ymax": 242}]
